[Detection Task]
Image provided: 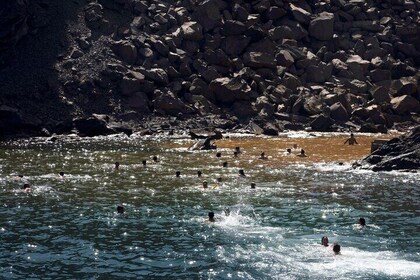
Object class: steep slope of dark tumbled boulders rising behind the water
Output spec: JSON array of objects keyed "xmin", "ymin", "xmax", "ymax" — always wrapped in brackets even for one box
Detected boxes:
[{"xmin": 0, "ymin": 0, "xmax": 420, "ymax": 138}]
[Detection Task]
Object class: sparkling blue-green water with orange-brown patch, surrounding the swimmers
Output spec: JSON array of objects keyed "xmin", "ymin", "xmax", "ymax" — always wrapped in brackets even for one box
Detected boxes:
[{"xmin": 0, "ymin": 135, "xmax": 420, "ymax": 279}]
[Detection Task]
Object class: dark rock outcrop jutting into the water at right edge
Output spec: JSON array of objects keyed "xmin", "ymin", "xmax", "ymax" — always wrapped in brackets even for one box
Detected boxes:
[{"xmin": 354, "ymin": 126, "xmax": 420, "ymax": 171}]
